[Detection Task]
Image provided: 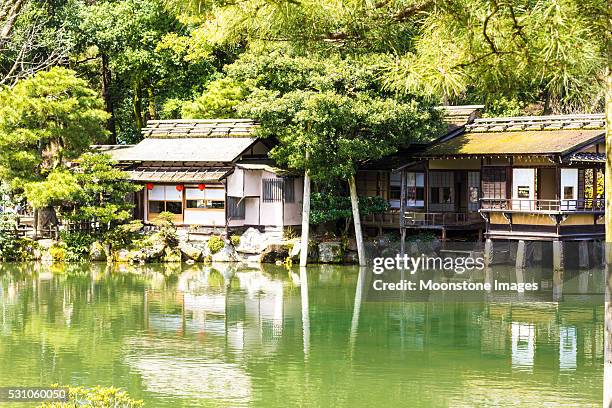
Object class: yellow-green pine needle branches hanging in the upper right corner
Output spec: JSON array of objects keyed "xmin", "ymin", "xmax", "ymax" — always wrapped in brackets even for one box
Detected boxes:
[{"xmin": 386, "ymin": 0, "xmax": 609, "ymax": 111}]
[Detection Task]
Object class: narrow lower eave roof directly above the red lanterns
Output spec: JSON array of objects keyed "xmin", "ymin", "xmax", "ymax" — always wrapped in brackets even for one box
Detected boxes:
[{"xmin": 128, "ymin": 167, "xmax": 231, "ymax": 183}]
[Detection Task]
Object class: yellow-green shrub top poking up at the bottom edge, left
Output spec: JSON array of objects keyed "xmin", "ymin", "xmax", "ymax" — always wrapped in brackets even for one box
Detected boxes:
[{"xmin": 38, "ymin": 386, "xmax": 144, "ymax": 408}]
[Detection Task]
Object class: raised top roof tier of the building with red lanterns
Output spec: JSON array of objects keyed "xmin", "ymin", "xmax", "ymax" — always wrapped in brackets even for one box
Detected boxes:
[{"xmin": 142, "ymin": 119, "xmax": 257, "ymax": 138}]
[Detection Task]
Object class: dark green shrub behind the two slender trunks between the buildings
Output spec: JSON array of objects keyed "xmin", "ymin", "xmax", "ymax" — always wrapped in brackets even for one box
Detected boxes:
[{"xmin": 310, "ymin": 193, "xmax": 389, "ymax": 224}]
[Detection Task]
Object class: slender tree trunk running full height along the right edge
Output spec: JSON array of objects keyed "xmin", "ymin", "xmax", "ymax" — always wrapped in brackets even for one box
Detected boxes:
[{"xmin": 603, "ymin": 0, "xmax": 612, "ymax": 408}]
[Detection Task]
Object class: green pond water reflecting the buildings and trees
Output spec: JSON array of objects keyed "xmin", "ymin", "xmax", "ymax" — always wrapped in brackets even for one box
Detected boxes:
[{"xmin": 0, "ymin": 264, "xmax": 603, "ymax": 408}]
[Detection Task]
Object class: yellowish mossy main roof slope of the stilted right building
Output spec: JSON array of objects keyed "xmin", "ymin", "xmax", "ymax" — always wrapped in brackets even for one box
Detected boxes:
[{"xmin": 422, "ymin": 129, "xmax": 604, "ymax": 157}]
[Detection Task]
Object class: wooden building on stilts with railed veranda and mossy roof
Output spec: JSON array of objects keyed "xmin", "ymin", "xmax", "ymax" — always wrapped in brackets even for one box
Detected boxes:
[{"xmin": 396, "ymin": 115, "xmax": 605, "ymax": 241}]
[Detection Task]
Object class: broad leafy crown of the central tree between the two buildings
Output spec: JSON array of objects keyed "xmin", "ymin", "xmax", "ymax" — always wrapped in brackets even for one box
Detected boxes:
[{"xmin": 227, "ymin": 51, "xmax": 442, "ymax": 181}]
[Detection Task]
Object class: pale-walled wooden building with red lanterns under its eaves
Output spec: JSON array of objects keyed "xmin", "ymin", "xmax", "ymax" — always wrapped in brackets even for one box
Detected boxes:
[{"xmin": 108, "ymin": 119, "xmax": 303, "ymax": 228}]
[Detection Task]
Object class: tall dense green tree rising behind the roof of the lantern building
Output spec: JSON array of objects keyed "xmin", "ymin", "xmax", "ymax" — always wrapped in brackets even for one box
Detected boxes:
[{"xmin": 72, "ymin": 0, "xmax": 216, "ymax": 142}]
